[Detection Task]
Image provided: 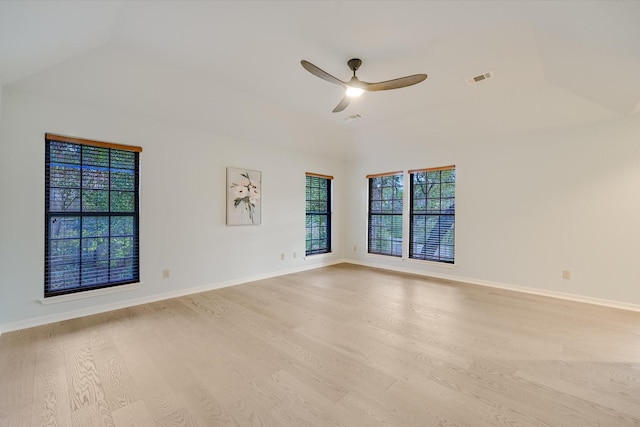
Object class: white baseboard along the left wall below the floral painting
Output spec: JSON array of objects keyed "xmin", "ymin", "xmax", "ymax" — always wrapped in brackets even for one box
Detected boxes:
[{"xmin": 0, "ymin": 259, "xmax": 345, "ymax": 335}]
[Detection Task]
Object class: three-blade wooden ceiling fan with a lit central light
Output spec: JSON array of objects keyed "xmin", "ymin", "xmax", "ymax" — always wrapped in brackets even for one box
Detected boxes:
[{"xmin": 300, "ymin": 58, "xmax": 427, "ymax": 113}]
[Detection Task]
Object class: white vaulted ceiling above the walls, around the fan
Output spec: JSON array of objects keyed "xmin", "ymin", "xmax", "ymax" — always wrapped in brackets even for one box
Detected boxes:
[{"xmin": 0, "ymin": 0, "xmax": 640, "ymax": 157}]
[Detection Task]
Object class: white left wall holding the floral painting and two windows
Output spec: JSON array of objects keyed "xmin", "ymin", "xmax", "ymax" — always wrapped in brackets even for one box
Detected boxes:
[{"xmin": 0, "ymin": 87, "xmax": 344, "ymax": 332}]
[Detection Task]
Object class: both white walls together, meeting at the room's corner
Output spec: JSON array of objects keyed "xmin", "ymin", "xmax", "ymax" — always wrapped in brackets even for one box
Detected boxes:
[{"xmin": 0, "ymin": 72, "xmax": 640, "ymax": 332}]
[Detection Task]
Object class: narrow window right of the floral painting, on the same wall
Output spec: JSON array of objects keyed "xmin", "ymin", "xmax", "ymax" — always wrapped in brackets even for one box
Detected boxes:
[{"xmin": 305, "ymin": 172, "xmax": 333, "ymax": 255}]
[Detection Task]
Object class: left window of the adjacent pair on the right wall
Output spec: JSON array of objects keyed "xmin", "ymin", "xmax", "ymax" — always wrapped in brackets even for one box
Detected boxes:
[{"xmin": 367, "ymin": 172, "xmax": 404, "ymax": 257}]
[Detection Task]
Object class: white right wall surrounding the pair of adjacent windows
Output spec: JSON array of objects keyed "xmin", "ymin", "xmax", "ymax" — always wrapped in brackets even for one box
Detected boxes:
[{"xmin": 344, "ymin": 116, "xmax": 640, "ymax": 308}]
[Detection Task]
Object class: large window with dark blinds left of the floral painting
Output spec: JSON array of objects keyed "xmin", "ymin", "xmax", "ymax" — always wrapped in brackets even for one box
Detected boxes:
[{"xmin": 44, "ymin": 134, "xmax": 142, "ymax": 297}]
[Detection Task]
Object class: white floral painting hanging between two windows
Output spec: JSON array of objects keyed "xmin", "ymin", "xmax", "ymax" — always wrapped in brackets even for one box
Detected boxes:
[{"xmin": 227, "ymin": 168, "xmax": 262, "ymax": 225}]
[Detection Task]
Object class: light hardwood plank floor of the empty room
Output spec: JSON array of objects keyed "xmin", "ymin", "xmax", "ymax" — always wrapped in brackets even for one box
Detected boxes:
[{"xmin": 0, "ymin": 264, "xmax": 640, "ymax": 427}]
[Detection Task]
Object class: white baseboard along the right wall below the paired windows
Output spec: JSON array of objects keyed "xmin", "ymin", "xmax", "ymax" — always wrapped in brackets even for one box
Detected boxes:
[{"xmin": 344, "ymin": 259, "xmax": 640, "ymax": 312}]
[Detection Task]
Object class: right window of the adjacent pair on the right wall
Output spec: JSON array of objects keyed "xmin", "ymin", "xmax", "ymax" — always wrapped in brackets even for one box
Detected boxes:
[{"xmin": 409, "ymin": 166, "xmax": 456, "ymax": 264}]
